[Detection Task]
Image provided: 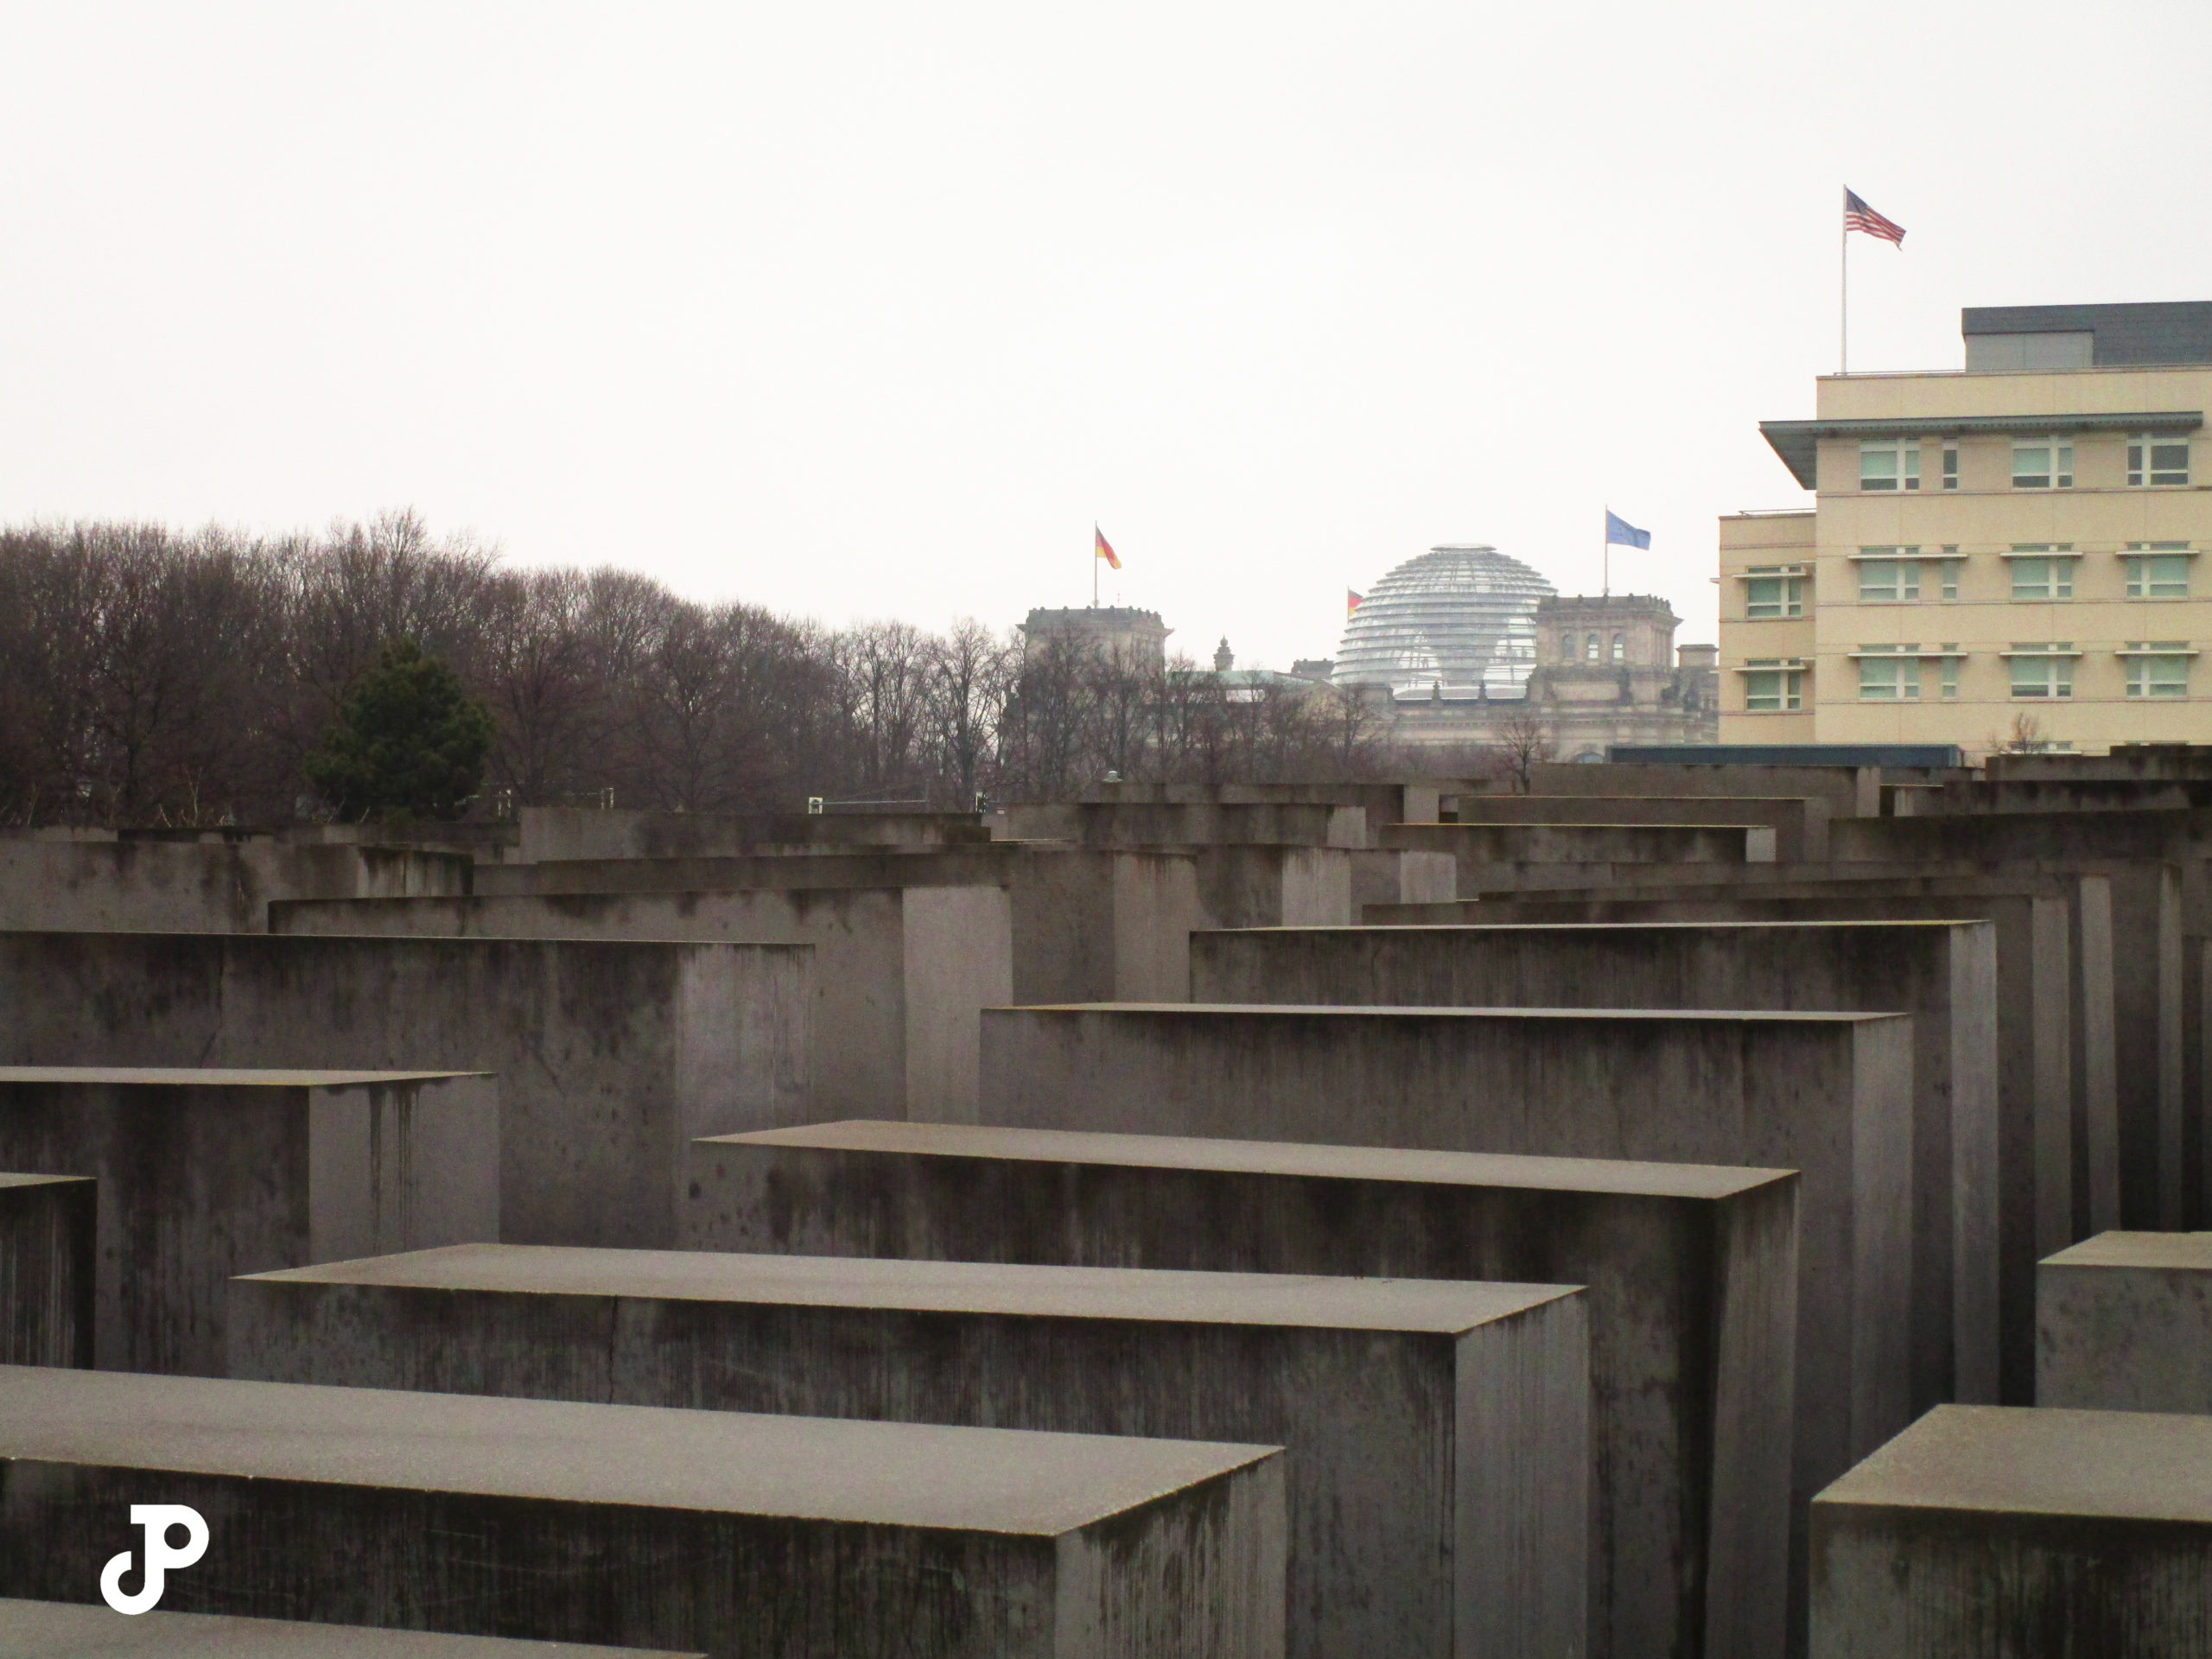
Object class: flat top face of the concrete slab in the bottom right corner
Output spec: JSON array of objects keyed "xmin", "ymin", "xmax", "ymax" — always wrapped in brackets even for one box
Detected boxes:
[{"xmin": 1814, "ymin": 1405, "xmax": 2212, "ymax": 1522}]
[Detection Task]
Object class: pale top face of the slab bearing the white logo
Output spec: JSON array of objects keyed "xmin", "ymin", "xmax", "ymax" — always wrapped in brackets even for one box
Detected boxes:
[{"xmin": 0, "ymin": 1365, "xmax": 1276, "ymax": 1537}]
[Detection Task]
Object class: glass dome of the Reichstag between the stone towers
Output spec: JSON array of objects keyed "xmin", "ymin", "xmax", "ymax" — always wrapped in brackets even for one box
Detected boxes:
[{"xmin": 1332, "ymin": 546, "xmax": 1555, "ymax": 696}]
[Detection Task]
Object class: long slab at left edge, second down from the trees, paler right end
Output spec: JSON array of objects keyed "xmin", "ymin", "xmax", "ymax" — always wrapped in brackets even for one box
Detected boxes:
[{"xmin": 0, "ymin": 933, "xmax": 812, "ymax": 1248}]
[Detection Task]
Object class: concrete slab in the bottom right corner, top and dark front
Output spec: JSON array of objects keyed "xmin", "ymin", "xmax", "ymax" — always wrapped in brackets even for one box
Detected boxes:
[{"xmin": 1812, "ymin": 1405, "xmax": 2212, "ymax": 1659}]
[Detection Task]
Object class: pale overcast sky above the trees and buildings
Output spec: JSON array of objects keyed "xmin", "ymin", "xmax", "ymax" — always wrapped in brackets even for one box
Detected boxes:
[{"xmin": 0, "ymin": 0, "xmax": 2212, "ymax": 668}]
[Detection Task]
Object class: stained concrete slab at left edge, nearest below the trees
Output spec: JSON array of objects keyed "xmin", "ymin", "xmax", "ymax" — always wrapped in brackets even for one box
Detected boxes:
[{"xmin": 0, "ymin": 830, "xmax": 469, "ymax": 933}]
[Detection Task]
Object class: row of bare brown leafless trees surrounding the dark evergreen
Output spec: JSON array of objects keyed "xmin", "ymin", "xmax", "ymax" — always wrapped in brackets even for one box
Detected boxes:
[{"xmin": 0, "ymin": 513, "xmax": 1402, "ymax": 830}]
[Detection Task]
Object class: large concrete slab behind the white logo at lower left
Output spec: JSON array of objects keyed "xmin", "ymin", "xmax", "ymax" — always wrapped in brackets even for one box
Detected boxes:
[{"xmin": 0, "ymin": 1367, "xmax": 1283, "ymax": 1659}]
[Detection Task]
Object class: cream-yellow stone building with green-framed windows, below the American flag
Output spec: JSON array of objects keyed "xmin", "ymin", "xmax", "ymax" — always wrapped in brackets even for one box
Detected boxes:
[{"xmin": 1721, "ymin": 303, "xmax": 2212, "ymax": 757}]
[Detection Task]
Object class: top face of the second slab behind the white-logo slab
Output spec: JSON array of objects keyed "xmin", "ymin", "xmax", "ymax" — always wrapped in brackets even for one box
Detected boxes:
[{"xmin": 692, "ymin": 1117, "xmax": 1796, "ymax": 1199}]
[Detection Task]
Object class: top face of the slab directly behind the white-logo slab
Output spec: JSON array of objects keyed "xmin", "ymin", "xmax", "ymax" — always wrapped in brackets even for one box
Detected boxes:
[{"xmin": 244, "ymin": 1243, "xmax": 1573, "ymax": 1336}]
